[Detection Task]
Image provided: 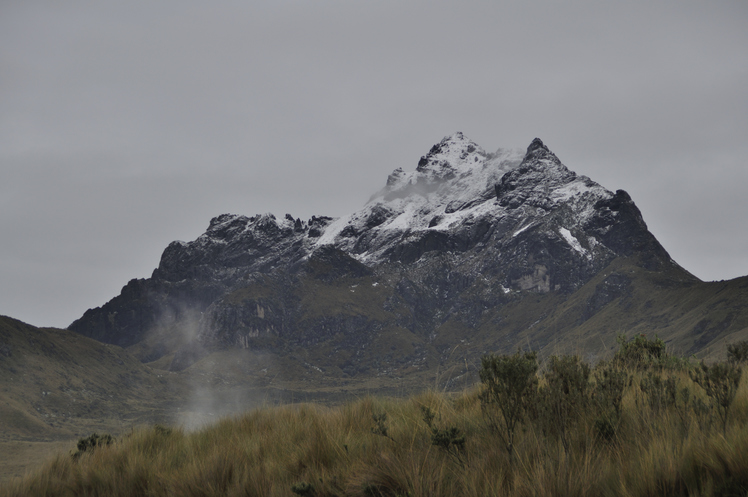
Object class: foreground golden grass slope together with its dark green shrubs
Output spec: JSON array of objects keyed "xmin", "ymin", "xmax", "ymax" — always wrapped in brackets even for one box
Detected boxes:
[{"xmin": 0, "ymin": 336, "xmax": 748, "ymax": 496}]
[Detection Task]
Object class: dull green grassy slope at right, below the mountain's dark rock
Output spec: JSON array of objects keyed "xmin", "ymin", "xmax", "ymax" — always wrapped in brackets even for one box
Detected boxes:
[{"xmin": 434, "ymin": 258, "xmax": 748, "ymax": 370}]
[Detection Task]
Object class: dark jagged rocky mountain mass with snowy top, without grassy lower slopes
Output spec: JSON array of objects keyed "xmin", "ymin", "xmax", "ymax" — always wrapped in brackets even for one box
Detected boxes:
[{"xmin": 70, "ymin": 133, "xmax": 695, "ymax": 374}]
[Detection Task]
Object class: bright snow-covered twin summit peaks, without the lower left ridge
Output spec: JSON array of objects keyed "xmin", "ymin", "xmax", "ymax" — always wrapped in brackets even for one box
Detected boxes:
[{"xmin": 316, "ymin": 132, "xmax": 612, "ymax": 262}]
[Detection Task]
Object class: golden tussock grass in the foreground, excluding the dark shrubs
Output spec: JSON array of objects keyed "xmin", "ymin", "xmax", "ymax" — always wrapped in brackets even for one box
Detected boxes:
[{"xmin": 0, "ymin": 350, "xmax": 748, "ymax": 497}]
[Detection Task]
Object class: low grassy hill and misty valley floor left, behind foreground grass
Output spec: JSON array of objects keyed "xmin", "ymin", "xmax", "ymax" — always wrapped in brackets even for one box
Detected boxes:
[{"xmin": 0, "ymin": 316, "xmax": 425, "ymax": 482}]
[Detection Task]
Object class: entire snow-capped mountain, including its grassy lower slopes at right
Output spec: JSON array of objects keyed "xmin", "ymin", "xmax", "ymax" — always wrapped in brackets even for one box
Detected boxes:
[{"xmin": 69, "ymin": 133, "xmax": 748, "ymax": 382}]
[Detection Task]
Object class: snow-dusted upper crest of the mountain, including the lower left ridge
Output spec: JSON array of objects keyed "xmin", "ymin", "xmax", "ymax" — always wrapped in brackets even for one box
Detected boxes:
[{"xmin": 180, "ymin": 133, "xmax": 618, "ymax": 268}]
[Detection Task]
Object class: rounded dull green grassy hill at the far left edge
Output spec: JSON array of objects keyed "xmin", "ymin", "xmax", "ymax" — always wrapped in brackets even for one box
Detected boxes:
[{"xmin": 0, "ymin": 316, "xmax": 179, "ymax": 442}]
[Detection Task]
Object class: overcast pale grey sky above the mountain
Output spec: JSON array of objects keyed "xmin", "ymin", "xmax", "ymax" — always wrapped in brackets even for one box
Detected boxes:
[{"xmin": 0, "ymin": 0, "xmax": 748, "ymax": 327}]
